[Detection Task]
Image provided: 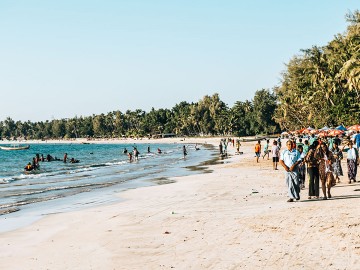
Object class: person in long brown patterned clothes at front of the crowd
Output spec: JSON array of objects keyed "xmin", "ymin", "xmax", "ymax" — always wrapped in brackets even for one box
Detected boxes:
[{"xmin": 315, "ymin": 142, "xmax": 336, "ymax": 200}]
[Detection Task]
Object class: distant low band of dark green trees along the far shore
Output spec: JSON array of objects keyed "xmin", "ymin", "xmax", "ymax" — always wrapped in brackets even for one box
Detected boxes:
[{"xmin": 0, "ymin": 92, "xmax": 280, "ymax": 140}]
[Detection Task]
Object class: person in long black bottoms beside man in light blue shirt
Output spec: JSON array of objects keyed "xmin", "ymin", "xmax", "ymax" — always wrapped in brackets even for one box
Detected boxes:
[{"xmin": 305, "ymin": 141, "xmax": 320, "ymax": 199}]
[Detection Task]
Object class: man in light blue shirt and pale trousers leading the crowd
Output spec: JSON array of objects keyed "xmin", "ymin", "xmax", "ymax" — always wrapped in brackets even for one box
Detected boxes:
[{"xmin": 280, "ymin": 140, "xmax": 301, "ymax": 202}]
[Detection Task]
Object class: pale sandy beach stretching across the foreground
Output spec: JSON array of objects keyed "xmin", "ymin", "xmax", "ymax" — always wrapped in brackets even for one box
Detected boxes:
[{"xmin": 0, "ymin": 138, "xmax": 360, "ymax": 270}]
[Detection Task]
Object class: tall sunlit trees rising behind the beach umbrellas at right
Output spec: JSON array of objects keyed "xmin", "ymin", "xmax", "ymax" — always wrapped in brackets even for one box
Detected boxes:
[{"xmin": 274, "ymin": 11, "xmax": 360, "ymax": 130}]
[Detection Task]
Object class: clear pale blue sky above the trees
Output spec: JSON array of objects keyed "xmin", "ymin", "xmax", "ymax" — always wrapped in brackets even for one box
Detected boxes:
[{"xmin": 0, "ymin": 0, "xmax": 360, "ymax": 122}]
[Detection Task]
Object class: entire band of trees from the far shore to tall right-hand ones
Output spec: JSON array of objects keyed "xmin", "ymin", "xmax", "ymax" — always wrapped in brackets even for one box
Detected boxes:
[{"xmin": 0, "ymin": 11, "xmax": 360, "ymax": 139}]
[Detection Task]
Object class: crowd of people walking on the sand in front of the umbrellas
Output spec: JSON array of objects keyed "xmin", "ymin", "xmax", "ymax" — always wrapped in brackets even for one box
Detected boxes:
[{"xmin": 255, "ymin": 132, "xmax": 360, "ymax": 202}]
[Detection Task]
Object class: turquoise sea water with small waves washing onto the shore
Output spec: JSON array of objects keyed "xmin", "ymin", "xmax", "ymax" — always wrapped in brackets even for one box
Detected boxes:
[{"xmin": 0, "ymin": 143, "xmax": 215, "ymax": 231}]
